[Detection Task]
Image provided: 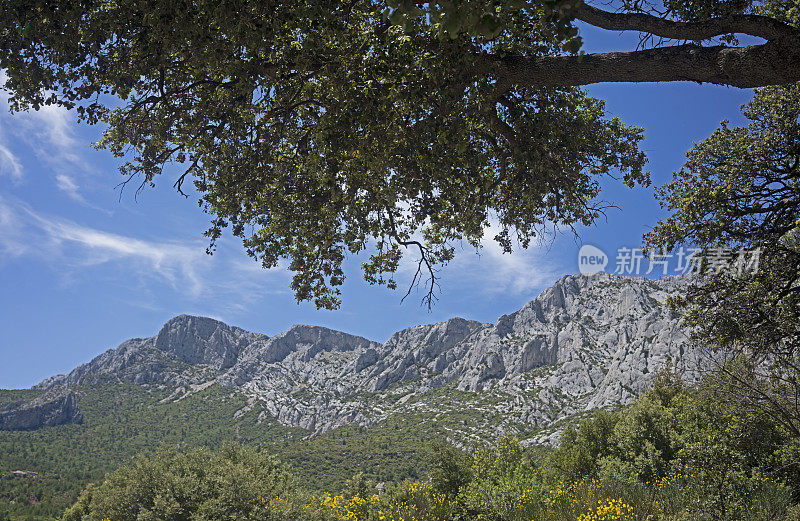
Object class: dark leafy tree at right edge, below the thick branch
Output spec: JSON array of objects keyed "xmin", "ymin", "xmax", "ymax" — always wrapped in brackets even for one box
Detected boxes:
[{"xmin": 646, "ymin": 84, "xmax": 800, "ymax": 435}]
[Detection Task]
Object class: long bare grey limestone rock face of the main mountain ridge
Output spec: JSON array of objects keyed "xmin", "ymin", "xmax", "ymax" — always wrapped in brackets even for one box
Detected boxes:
[{"xmin": 28, "ymin": 273, "xmax": 704, "ymax": 432}]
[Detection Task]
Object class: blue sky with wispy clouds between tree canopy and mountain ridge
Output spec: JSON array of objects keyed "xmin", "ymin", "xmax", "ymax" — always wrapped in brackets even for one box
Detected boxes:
[{"xmin": 0, "ymin": 29, "xmax": 752, "ymax": 388}]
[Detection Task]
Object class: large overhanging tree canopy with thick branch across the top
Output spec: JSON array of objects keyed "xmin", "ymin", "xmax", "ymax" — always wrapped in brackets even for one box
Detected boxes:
[{"xmin": 0, "ymin": 0, "xmax": 800, "ymax": 308}]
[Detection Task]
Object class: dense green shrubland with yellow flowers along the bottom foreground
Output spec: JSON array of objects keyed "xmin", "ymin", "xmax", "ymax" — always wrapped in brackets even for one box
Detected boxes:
[{"xmin": 59, "ymin": 366, "xmax": 800, "ymax": 521}]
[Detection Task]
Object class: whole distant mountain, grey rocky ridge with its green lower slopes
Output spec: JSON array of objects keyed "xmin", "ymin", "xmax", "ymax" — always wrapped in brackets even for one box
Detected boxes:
[{"xmin": 0, "ymin": 274, "xmax": 702, "ymax": 515}]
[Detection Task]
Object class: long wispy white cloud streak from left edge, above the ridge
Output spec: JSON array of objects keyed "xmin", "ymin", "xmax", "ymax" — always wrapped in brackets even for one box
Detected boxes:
[{"xmin": 0, "ymin": 196, "xmax": 288, "ymax": 304}]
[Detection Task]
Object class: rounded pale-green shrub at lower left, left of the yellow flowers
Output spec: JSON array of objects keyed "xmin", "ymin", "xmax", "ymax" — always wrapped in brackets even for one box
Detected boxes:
[{"xmin": 63, "ymin": 444, "xmax": 324, "ymax": 521}]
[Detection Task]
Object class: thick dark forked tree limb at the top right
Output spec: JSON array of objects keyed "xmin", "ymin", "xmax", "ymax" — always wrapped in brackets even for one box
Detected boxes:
[{"xmin": 483, "ymin": 5, "xmax": 800, "ymax": 88}]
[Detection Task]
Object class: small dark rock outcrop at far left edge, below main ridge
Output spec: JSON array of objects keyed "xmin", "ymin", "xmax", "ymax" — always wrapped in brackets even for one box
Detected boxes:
[{"xmin": 0, "ymin": 388, "xmax": 83, "ymax": 430}]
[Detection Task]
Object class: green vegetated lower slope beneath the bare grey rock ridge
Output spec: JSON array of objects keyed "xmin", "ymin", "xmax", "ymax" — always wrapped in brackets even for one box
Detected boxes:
[{"xmin": 0, "ymin": 380, "xmax": 544, "ymax": 519}]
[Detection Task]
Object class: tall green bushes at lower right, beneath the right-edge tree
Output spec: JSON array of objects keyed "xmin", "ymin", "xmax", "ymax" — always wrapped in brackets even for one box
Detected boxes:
[{"xmin": 542, "ymin": 371, "xmax": 800, "ymax": 519}]
